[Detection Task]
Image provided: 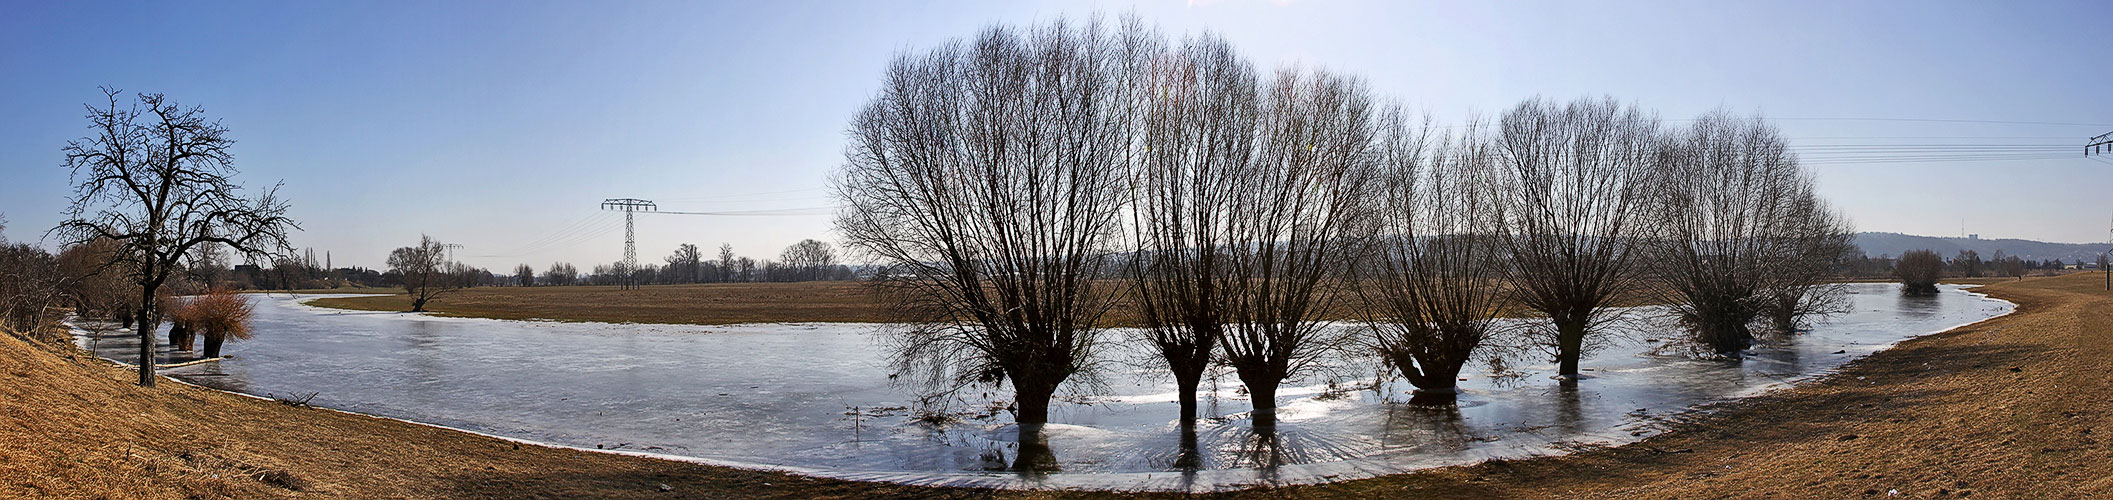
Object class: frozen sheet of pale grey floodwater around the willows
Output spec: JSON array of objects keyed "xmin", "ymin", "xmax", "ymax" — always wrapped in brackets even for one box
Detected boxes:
[{"xmin": 82, "ymin": 285, "xmax": 2012, "ymax": 492}]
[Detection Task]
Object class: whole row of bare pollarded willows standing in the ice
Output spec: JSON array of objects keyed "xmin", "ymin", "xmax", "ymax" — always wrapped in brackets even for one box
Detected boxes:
[{"xmin": 835, "ymin": 21, "xmax": 1843, "ymax": 424}]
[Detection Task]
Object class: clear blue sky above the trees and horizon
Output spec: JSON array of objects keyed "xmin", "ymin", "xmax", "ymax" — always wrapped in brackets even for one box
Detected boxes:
[{"xmin": 0, "ymin": 0, "xmax": 2113, "ymax": 270}]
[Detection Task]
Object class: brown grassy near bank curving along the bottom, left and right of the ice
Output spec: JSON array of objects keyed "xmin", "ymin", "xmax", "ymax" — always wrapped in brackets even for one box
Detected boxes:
[{"xmin": 0, "ymin": 274, "xmax": 2113, "ymax": 498}]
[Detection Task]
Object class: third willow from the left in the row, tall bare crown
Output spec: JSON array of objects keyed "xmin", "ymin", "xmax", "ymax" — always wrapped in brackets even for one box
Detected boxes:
[{"xmin": 1221, "ymin": 70, "xmax": 1376, "ymax": 413}]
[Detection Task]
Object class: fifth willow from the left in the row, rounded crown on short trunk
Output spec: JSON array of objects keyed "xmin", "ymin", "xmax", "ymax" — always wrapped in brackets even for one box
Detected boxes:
[{"xmin": 1490, "ymin": 99, "xmax": 1659, "ymax": 380}]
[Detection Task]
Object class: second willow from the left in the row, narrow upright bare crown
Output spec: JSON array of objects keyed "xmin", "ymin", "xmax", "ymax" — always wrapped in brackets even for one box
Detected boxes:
[{"xmin": 1126, "ymin": 36, "xmax": 1257, "ymax": 426}]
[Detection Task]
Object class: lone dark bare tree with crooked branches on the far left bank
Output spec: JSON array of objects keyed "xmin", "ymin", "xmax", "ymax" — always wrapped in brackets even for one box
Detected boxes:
[{"xmin": 53, "ymin": 89, "xmax": 300, "ymax": 386}]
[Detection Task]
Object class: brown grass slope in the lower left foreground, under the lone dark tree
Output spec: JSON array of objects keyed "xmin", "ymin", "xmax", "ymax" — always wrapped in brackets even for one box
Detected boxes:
[{"xmin": 0, "ymin": 327, "xmax": 997, "ymax": 498}]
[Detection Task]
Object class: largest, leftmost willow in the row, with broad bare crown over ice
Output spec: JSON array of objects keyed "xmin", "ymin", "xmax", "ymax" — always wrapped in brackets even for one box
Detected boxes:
[{"xmin": 833, "ymin": 21, "xmax": 1130, "ymax": 428}]
